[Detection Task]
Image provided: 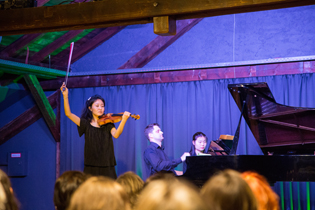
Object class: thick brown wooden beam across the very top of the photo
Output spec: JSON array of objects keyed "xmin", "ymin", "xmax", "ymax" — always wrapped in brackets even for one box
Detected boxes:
[{"xmin": 0, "ymin": 0, "xmax": 315, "ymax": 36}]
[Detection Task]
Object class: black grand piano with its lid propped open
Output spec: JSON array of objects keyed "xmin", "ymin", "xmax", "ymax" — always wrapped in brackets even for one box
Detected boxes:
[{"xmin": 183, "ymin": 83, "xmax": 315, "ymax": 186}]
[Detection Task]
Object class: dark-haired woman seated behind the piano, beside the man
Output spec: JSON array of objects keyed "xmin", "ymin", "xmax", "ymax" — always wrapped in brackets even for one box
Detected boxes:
[{"xmin": 183, "ymin": 132, "xmax": 208, "ymax": 173}]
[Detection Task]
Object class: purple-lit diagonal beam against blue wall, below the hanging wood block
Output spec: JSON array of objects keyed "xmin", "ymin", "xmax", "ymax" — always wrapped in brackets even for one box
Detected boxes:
[{"xmin": 118, "ymin": 18, "xmax": 202, "ymax": 69}]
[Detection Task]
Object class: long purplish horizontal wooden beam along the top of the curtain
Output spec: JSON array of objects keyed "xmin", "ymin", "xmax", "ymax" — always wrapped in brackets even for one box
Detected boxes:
[{"xmin": 40, "ymin": 61, "xmax": 315, "ymax": 90}]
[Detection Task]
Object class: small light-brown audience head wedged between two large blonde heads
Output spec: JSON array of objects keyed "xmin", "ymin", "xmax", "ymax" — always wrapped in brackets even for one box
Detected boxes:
[{"xmin": 116, "ymin": 171, "xmax": 144, "ymax": 209}]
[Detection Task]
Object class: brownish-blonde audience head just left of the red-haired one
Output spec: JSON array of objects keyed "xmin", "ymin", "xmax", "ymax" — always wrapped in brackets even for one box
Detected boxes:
[{"xmin": 201, "ymin": 169, "xmax": 257, "ymax": 210}]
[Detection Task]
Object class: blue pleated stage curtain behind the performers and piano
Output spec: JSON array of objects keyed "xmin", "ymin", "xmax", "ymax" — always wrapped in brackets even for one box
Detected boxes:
[{"xmin": 61, "ymin": 74, "xmax": 315, "ymax": 209}]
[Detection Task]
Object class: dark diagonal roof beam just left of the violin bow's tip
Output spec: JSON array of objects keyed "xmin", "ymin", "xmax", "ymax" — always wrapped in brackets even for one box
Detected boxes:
[{"xmin": 29, "ymin": 30, "xmax": 84, "ymax": 62}]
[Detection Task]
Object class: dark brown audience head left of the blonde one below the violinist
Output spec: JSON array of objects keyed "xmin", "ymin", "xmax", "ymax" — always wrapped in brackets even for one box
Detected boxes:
[{"xmin": 54, "ymin": 171, "xmax": 88, "ymax": 210}]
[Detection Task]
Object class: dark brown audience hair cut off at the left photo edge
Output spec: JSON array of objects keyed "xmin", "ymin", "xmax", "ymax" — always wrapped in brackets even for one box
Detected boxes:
[{"xmin": 0, "ymin": 169, "xmax": 19, "ymax": 210}]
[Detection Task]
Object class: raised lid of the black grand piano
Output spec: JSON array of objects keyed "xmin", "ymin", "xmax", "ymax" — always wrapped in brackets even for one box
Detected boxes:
[{"xmin": 228, "ymin": 83, "xmax": 315, "ymax": 154}]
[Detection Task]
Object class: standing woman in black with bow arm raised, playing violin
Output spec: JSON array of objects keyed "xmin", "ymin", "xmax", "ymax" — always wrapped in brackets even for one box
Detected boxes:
[{"xmin": 60, "ymin": 84, "xmax": 130, "ymax": 179}]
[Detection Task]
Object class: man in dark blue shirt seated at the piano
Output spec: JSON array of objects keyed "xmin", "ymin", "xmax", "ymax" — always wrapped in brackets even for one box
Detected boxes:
[{"xmin": 143, "ymin": 123, "xmax": 190, "ymax": 176}]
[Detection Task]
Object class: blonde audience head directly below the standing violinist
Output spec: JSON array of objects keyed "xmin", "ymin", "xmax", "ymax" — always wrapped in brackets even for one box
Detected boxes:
[{"xmin": 68, "ymin": 176, "xmax": 130, "ymax": 210}]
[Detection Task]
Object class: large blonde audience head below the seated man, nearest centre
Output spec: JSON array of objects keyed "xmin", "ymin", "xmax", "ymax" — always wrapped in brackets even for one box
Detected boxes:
[{"xmin": 135, "ymin": 179, "xmax": 206, "ymax": 210}]
